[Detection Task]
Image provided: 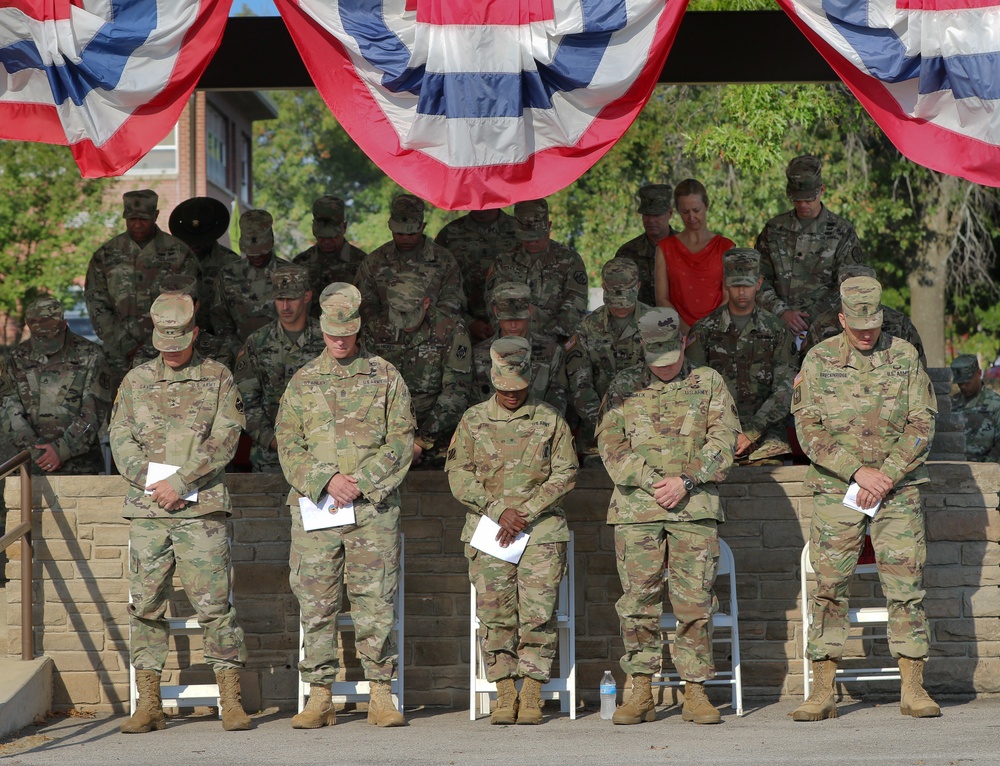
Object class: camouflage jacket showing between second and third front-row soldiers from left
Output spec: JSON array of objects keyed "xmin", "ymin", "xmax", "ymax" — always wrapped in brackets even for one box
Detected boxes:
[{"xmin": 361, "ymin": 306, "xmax": 472, "ymax": 449}]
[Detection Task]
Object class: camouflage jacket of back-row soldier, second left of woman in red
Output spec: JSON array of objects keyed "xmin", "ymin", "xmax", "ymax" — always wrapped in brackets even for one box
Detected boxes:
[{"xmin": 486, "ymin": 241, "xmax": 589, "ymax": 343}]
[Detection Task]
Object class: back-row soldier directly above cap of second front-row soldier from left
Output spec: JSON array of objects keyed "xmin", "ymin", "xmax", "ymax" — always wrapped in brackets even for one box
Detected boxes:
[{"xmin": 292, "ymin": 194, "xmax": 368, "ymax": 319}]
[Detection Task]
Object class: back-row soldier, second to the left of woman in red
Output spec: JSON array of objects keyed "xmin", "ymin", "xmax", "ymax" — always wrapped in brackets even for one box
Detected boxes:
[{"xmin": 486, "ymin": 199, "xmax": 588, "ymax": 343}]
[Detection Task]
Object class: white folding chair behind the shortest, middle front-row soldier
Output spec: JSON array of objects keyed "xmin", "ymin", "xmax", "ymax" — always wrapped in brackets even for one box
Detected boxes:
[{"xmin": 469, "ymin": 532, "xmax": 576, "ymax": 721}]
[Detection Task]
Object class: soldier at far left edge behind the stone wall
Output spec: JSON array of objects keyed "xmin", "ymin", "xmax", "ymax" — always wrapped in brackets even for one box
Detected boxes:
[{"xmin": 0, "ymin": 298, "xmax": 114, "ymax": 474}]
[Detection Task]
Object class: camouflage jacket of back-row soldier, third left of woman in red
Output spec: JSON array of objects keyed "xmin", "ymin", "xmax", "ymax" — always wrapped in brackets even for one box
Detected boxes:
[{"xmin": 354, "ymin": 236, "xmax": 465, "ymax": 323}]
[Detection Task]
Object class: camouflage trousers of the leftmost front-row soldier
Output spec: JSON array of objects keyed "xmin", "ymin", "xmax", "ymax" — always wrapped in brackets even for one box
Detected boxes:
[{"xmin": 128, "ymin": 512, "xmax": 247, "ymax": 673}]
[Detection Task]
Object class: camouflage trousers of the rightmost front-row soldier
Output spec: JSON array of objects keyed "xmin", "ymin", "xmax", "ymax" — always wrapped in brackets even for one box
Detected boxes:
[{"xmin": 808, "ymin": 487, "xmax": 928, "ymax": 660}]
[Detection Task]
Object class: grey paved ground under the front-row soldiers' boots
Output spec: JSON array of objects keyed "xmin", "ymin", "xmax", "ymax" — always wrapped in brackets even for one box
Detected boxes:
[{"xmin": 0, "ymin": 699, "xmax": 1000, "ymax": 766}]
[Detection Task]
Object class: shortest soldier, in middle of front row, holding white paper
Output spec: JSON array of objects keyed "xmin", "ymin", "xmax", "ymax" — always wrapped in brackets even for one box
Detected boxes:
[{"xmin": 445, "ymin": 337, "xmax": 577, "ymax": 724}]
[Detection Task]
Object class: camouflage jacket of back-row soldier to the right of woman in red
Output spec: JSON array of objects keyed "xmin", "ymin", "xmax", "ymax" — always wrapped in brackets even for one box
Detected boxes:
[{"xmin": 754, "ymin": 206, "xmax": 864, "ymax": 320}]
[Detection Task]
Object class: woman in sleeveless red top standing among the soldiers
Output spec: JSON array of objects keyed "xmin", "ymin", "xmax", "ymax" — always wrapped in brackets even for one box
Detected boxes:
[{"xmin": 656, "ymin": 178, "xmax": 734, "ymax": 330}]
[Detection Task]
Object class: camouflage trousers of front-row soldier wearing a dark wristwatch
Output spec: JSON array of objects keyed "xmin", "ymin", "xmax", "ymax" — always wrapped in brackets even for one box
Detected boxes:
[{"xmin": 615, "ymin": 519, "xmax": 719, "ymax": 681}]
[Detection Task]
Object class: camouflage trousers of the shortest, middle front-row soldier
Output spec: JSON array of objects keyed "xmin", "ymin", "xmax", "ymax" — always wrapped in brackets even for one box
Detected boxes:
[{"xmin": 465, "ymin": 543, "xmax": 566, "ymax": 683}]
